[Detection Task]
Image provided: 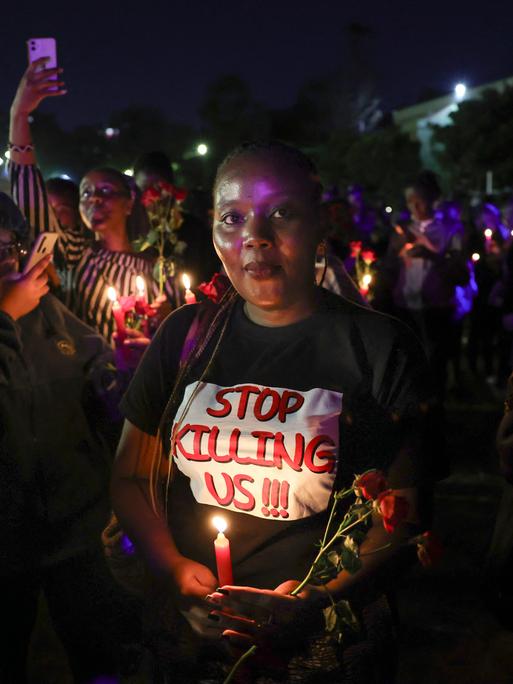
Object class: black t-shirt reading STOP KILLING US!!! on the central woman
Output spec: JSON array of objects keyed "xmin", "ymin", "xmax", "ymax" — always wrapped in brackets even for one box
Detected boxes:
[{"xmin": 122, "ymin": 291, "xmax": 428, "ymax": 588}]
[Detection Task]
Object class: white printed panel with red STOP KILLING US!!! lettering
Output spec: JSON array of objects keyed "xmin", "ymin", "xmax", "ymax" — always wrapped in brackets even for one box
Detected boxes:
[{"xmin": 173, "ymin": 382, "xmax": 342, "ymax": 520}]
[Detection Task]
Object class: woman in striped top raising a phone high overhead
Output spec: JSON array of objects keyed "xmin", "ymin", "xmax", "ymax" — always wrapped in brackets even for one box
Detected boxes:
[{"xmin": 9, "ymin": 58, "xmax": 171, "ymax": 341}]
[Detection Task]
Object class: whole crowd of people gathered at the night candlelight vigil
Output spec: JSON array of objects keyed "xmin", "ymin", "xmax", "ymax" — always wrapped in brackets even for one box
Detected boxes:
[{"xmin": 0, "ymin": 59, "xmax": 513, "ymax": 684}]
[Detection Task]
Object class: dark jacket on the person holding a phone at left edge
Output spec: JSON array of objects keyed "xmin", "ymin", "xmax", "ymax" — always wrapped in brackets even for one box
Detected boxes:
[{"xmin": 0, "ymin": 295, "xmax": 122, "ymax": 575}]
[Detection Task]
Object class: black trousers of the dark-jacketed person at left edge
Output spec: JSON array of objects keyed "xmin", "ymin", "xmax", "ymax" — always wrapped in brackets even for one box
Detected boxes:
[{"xmin": 0, "ymin": 550, "xmax": 140, "ymax": 684}]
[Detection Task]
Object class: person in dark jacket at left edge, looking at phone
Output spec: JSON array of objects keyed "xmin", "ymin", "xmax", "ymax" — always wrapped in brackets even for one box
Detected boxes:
[{"xmin": 0, "ymin": 193, "xmax": 140, "ymax": 684}]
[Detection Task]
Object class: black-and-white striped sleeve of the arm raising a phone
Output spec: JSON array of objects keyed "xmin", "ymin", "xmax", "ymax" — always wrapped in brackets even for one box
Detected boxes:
[{"xmin": 9, "ymin": 162, "xmax": 85, "ymax": 266}]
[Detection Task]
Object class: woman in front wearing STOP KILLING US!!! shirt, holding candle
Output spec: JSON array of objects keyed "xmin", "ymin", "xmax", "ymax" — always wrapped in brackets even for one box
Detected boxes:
[{"xmin": 111, "ymin": 141, "xmax": 431, "ymax": 682}]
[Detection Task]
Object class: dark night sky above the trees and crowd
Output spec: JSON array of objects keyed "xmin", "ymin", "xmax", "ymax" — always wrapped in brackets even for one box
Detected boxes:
[{"xmin": 0, "ymin": 0, "xmax": 513, "ymax": 127}]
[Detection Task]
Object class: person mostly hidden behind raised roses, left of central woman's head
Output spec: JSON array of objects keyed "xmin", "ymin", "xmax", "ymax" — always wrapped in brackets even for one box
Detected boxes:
[{"xmin": 134, "ymin": 151, "xmax": 219, "ymax": 284}]
